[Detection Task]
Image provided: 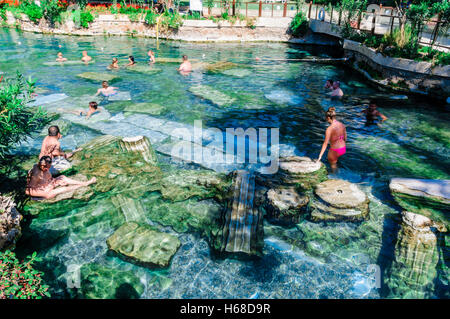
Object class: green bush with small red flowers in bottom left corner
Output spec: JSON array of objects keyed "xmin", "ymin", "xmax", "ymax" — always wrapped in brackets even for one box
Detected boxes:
[{"xmin": 0, "ymin": 250, "xmax": 50, "ymax": 299}]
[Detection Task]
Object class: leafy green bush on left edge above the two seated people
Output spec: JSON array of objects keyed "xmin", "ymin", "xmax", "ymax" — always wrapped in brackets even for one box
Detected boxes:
[{"xmin": 0, "ymin": 73, "xmax": 52, "ymax": 161}]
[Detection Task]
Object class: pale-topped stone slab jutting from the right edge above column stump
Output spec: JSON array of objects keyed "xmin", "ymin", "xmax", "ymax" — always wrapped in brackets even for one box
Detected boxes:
[{"xmin": 389, "ymin": 178, "xmax": 450, "ymax": 228}]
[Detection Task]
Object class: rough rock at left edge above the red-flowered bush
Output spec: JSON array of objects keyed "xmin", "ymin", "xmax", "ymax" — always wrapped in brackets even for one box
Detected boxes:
[{"xmin": 0, "ymin": 195, "xmax": 22, "ymax": 250}]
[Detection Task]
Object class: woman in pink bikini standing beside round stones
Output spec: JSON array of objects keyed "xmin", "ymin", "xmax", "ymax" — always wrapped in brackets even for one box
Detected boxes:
[{"xmin": 317, "ymin": 107, "xmax": 347, "ymax": 173}]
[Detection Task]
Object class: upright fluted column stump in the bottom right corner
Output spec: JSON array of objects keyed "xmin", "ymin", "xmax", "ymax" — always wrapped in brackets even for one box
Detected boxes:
[{"xmin": 385, "ymin": 212, "xmax": 442, "ymax": 298}]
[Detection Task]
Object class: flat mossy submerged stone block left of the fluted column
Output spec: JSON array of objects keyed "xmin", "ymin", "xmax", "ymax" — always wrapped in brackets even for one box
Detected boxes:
[{"xmin": 106, "ymin": 222, "xmax": 181, "ymax": 267}]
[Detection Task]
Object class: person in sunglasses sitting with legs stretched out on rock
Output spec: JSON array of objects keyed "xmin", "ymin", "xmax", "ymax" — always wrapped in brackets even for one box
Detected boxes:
[{"xmin": 25, "ymin": 156, "xmax": 96, "ymax": 199}]
